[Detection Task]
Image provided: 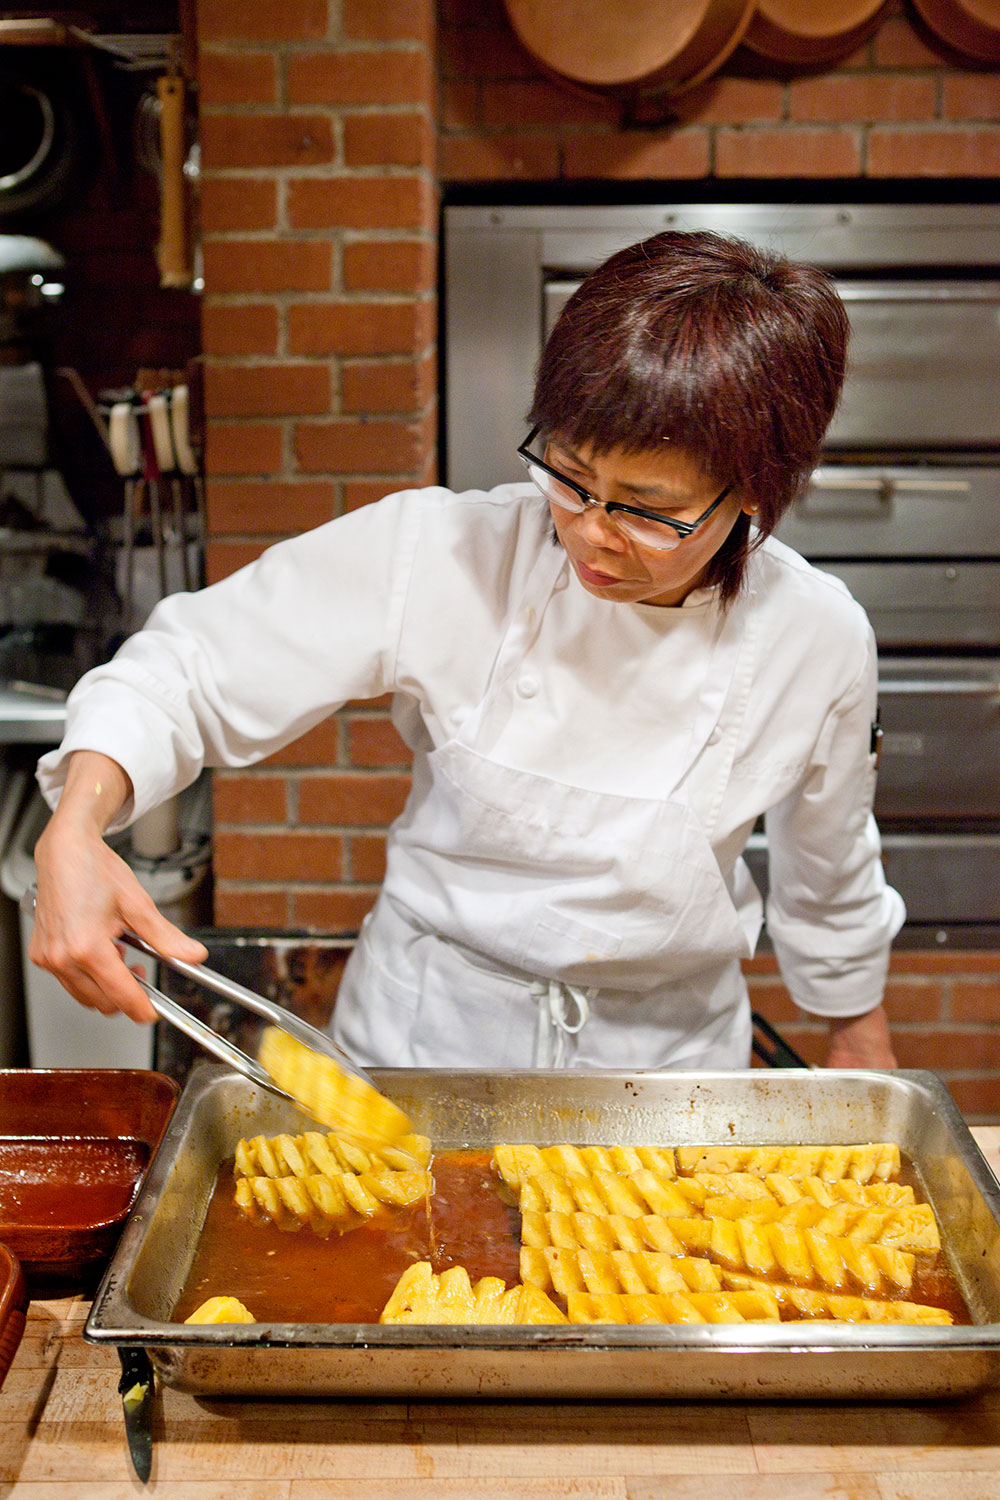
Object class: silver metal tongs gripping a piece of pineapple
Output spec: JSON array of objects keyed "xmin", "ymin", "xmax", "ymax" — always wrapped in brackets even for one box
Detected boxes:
[{"xmin": 21, "ymin": 887, "xmax": 378, "ymax": 1110}]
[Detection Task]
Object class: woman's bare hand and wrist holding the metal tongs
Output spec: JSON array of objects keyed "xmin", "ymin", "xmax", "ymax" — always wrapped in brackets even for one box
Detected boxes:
[{"xmin": 28, "ymin": 750, "xmax": 207, "ymax": 1022}]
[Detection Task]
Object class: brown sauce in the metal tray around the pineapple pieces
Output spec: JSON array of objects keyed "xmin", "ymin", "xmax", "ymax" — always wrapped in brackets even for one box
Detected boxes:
[{"xmin": 174, "ymin": 1151, "xmax": 972, "ymax": 1323}]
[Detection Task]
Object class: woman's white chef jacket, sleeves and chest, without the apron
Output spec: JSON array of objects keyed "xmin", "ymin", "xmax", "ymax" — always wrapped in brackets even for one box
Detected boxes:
[{"xmin": 39, "ymin": 485, "xmax": 904, "ymax": 1017}]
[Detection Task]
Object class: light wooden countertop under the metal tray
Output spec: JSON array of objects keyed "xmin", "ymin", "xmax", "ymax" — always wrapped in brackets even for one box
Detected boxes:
[{"xmin": 0, "ymin": 1127, "xmax": 1000, "ymax": 1500}]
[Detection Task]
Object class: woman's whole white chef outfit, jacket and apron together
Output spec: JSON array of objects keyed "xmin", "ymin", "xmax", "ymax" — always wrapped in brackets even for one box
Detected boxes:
[{"xmin": 39, "ymin": 485, "xmax": 903, "ymax": 1068}]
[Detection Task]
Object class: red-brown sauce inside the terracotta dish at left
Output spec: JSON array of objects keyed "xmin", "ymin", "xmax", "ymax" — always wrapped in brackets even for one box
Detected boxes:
[{"xmin": 0, "ymin": 1136, "xmax": 150, "ymax": 1239}]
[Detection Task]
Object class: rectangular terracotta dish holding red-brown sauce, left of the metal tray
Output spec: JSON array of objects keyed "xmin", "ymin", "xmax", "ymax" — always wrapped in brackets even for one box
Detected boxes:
[{"xmin": 0, "ymin": 1068, "xmax": 178, "ymax": 1296}]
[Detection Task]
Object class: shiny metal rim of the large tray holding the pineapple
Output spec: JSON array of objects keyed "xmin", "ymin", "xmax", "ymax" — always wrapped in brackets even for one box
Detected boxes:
[{"xmin": 84, "ymin": 1064, "xmax": 1000, "ymax": 1355}]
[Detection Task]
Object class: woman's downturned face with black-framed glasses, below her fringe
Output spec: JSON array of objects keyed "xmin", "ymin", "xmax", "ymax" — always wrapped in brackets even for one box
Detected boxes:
[{"xmin": 546, "ymin": 438, "xmax": 751, "ymax": 606}]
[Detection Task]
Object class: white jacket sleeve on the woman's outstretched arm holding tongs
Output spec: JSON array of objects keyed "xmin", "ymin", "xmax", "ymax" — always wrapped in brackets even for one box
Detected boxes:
[{"xmin": 37, "ymin": 494, "xmax": 418, "ymax": 833}]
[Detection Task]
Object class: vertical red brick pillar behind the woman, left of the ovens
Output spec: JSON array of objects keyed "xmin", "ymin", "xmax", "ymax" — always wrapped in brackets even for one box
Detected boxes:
[{"xmin": 198, "ymin": 0, "xmax": 436, "ymax": 932}]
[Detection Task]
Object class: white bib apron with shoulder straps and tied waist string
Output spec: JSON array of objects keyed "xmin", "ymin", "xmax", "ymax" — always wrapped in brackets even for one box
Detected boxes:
[{"xmin": 333, "ymin": 546, "xmax": 753, "ymax": 1070}]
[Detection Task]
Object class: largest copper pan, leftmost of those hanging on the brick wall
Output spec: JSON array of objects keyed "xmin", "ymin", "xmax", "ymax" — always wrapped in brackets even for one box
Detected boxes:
[{"xmin": 505, "ymin": 0, "xmax": 756, "ymax": 96}]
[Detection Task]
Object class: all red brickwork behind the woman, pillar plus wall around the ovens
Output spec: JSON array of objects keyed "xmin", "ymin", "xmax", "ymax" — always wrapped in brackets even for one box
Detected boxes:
[{"xmin": 198, "ymin": 0, "xmax": 1000, "ymax": 1116}]
